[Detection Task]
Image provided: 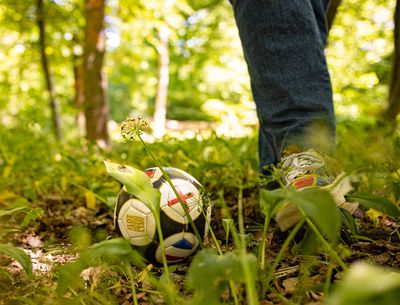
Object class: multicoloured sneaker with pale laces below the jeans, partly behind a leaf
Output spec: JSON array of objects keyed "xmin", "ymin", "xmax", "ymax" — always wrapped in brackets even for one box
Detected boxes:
[{"xmin": 275, "ymin": 149, "xmax": 357, "ymax": 231}]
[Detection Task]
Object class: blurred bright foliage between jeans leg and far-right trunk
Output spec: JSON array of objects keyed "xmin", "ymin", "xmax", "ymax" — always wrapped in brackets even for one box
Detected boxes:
[{"xmin": 327, "ymin": 0, "xmax": 395, "ymax": 119}]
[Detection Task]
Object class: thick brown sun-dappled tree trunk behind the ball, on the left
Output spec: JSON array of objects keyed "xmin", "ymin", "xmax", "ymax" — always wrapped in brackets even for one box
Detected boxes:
[{"xmin": 83, "ymin": 0, "xmax": 110, "ymax": 148}]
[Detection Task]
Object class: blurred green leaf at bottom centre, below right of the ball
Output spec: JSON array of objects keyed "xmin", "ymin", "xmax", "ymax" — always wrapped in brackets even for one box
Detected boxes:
[{"xmin": 187, "ymin": 249, "xmax": 257, "ymax": 305}]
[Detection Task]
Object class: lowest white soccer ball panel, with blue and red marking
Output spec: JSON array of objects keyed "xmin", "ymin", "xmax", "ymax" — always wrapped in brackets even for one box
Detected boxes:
[{"xmin": 155, "ymin": 232, "xmax": 199, "ymax": 263}]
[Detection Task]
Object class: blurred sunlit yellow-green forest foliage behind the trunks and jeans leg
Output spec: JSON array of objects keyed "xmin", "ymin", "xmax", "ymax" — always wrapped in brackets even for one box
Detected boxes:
[{"xmin": 0, "ymin": 0, "xmax": 395, "ymax": 139}]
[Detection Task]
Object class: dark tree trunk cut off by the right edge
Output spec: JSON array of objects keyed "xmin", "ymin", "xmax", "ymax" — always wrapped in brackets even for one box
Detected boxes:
[{"xmin": 384, "ymin": 0, "xmax": 400, "ymax": 125}]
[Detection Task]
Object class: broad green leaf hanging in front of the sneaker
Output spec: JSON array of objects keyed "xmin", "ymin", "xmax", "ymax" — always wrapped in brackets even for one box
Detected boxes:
[{"xmin": 288, "ymin": 188, "xmax": 341, "ymax": 242}]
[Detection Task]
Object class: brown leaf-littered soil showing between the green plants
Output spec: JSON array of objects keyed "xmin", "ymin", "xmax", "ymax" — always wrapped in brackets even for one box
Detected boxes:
[{"xmin": 0, "ymin": 189, "xmax": 400, "ymax": 305}]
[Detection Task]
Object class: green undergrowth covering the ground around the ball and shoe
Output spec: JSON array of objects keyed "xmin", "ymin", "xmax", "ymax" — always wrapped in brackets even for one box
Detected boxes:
[{"xmin": 0, "ymin": 117, "xmax": 400, "ymax": 305}]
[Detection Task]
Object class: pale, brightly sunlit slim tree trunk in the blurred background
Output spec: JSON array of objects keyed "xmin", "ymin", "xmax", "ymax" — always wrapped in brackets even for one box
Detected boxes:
[{"xmin": 153, "ymin": 25, "xmax": 169, "ymax": 137}]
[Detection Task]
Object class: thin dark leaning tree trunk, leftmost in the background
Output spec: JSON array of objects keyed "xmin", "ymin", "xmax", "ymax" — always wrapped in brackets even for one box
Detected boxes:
[{"xmin": 37, "ymin": 0, "xmax": 62, "ymax": 141}]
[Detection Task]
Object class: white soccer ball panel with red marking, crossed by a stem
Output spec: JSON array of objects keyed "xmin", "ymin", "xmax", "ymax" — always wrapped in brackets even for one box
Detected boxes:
[{"xmin": 160, "ymin": 179, "xmax": 202, "ymax": 224}]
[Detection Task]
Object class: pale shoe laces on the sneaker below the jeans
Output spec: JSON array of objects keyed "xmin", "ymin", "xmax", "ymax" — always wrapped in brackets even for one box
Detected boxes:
[{"xmin": 281, "ymin": 149, "xmax": 325, "ymax": 185}]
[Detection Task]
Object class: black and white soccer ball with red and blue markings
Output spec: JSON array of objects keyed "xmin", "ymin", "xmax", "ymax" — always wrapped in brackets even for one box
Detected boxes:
[{"xmin": 114, "ymin": 167, "xmax": 211, "ymax": 263}]
